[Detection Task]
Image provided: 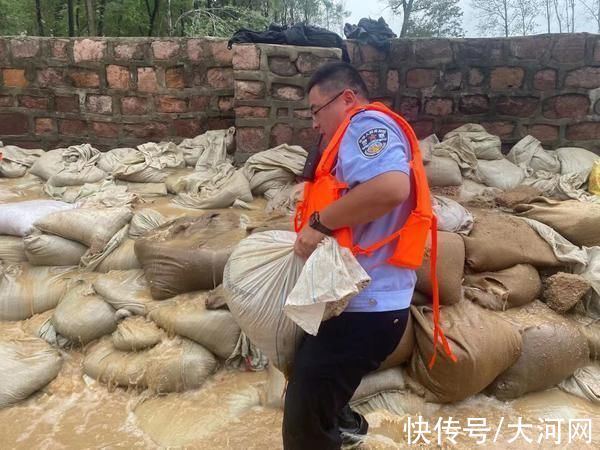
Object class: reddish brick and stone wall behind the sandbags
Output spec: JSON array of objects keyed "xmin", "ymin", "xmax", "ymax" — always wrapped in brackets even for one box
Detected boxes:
[{"xmin": 0, "ymin": 33, "xmax": 600, "ymax": 154}]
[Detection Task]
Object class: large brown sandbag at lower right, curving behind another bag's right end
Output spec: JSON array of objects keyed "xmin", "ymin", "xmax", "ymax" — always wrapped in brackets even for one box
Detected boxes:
[{"xmin": 487, "ymin": 302, "xmax": 589, "ymax": 400}]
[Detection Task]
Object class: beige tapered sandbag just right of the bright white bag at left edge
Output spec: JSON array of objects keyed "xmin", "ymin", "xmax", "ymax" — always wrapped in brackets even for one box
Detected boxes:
[{"xmin": 34, "ymin": 207, "xmax": 133, "ymax": 252}]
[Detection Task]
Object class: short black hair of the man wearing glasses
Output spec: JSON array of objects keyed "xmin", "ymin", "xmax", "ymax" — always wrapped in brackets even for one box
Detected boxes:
[{"xmin": 306, "ymin": 61, "xmax": 369, "ymax": 98}]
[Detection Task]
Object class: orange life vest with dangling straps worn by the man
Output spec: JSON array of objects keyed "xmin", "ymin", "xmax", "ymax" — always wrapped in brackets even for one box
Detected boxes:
[{"xmin": 294, "ymin": 103, "xmax": 456, "ymax": 368}]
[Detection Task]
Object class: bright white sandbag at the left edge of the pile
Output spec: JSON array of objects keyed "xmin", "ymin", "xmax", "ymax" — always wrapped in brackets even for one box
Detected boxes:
[{"xmin": 0, "ymin": 200, "xmax": 75, "ymax": 236}]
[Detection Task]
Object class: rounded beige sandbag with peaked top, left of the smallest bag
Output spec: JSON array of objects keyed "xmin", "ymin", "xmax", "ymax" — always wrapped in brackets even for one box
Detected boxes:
[{"xmin": 52, "ymin": 280, "xmax": 117, "ymax": 345}]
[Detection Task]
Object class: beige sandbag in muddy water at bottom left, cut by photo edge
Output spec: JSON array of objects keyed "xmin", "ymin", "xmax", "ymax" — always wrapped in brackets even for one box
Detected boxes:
[{"xmin": 0, "ymin": 338, "xmax": 62, "ymax": 408}]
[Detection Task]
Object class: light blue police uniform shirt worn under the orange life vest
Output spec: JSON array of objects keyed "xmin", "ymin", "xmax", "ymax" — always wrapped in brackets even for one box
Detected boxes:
[{"xmin": 335, "ymin": 110, "xmax": 417, "ymax": 312}]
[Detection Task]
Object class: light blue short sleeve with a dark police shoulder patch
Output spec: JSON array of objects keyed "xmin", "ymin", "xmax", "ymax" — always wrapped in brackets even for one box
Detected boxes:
[{"xmin": 338, "ymin": 114, "xmax": 410, "ymax": 187}]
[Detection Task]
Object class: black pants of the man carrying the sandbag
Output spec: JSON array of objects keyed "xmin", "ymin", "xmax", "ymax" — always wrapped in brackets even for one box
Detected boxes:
[{"xmin": 283, "ymin": 309, "xmax": 409, "ymax": 450}]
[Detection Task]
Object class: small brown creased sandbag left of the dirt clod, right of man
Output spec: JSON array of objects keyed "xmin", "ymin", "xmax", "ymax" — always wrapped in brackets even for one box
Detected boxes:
[{"xmin": 463, "ymin": 264, "xmax": 542, "ymax": 311}]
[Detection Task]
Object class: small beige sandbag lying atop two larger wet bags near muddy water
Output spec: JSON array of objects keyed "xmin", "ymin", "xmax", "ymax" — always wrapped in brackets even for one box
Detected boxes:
[{"xmin": 112, "ymin": 317, "xmax": 164, "ymax": 352}]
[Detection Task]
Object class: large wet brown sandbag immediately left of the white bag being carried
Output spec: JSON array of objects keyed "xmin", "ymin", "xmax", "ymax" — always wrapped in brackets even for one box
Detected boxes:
[{"xmin": 134, "ymin": 212, "xmax": 246, "ymax": 300}]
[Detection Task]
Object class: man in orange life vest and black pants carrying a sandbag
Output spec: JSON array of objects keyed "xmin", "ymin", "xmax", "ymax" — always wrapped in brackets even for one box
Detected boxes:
[{"xmin": 283, "ymin": 62, "xmax": 430, "ymax": 450}]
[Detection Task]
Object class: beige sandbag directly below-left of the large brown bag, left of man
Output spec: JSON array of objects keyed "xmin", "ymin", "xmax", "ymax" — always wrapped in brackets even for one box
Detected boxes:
[{"xmin": 93, "ymin": 270, "xmax": 155, "ymax": 316}]
